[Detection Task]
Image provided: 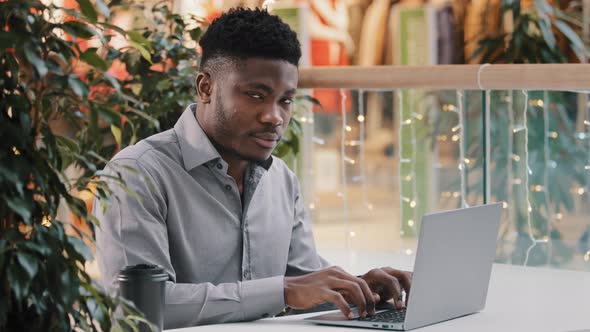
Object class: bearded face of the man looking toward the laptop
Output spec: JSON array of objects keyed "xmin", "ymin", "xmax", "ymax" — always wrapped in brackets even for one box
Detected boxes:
[{"xmin": 201, "ymin": 58, "xmax": 298, "ymax": 161}]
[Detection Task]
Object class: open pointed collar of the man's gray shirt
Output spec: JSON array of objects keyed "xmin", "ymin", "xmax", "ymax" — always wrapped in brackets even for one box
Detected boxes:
[{"xmin": 174, "ymin": 104, "xmax": 273, "ymax": 171}]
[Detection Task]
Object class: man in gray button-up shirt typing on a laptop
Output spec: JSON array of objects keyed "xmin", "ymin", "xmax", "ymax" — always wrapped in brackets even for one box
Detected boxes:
[{"xmin": 96, "ymin": 9, "xmax": 410, "ymax": 328}]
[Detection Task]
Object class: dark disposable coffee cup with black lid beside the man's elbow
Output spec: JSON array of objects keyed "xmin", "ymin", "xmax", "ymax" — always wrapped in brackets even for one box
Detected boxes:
[{"xmin": 117, "ymin": 264, "xmax": 168, "ymax": 332}]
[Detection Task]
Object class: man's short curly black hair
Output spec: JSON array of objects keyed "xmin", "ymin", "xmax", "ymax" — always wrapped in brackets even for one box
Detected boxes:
[{"xmin": 199, "ymin": 8, "xmax": 301, "ymax": 70}]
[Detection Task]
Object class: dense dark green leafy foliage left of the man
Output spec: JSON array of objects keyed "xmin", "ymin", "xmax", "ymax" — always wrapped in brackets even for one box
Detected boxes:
[{"xmin": 0, "ymin": 0, "xmax": 305, "ymax": 331}]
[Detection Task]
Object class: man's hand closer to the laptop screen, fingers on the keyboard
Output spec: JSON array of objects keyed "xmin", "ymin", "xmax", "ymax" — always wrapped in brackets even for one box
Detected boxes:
[{"xmin": 362, "ymin": 267, "xmax": 412, "ymax": 309}]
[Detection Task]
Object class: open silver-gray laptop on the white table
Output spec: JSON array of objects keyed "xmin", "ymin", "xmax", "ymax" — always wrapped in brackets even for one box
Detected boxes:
[{"xmin": 305, "ymin": 203, "xmax": 502, "ymax": 331}]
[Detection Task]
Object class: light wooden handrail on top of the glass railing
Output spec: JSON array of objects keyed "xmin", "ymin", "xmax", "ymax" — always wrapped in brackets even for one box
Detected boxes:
[{"xmin": 299, "ymin": 64, "xmax": 590, "ymax": 91}]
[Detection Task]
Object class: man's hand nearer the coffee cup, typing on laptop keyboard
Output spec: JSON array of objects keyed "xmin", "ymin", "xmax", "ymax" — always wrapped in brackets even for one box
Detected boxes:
[{"xmin": 285, "ymin": 266, "xmax": 379, "ymax": 319}]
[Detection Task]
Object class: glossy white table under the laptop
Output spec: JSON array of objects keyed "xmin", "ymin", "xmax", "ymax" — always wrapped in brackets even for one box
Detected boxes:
[{"xmin": 170, "ymin": 253, "xmax": 590, "ymax": 332}]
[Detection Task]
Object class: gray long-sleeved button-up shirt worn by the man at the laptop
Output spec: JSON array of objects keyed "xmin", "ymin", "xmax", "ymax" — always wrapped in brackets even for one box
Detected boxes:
[{"xmin": 94, "ymin": 105, "xmax": 328, "ymax": 328}]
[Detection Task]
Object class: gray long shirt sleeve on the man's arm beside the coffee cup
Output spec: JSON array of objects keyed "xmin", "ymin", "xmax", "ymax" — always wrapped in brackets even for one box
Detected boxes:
[{"xmin": 94, "ymin": 159, "xmax": 285, "ymax": 329}]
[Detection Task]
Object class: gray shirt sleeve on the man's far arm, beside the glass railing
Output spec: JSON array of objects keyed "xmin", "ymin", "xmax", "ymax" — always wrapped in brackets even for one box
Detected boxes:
[{"xmin": 285, "ymin": 179, "xmax": 331, "ymax": 276}]
